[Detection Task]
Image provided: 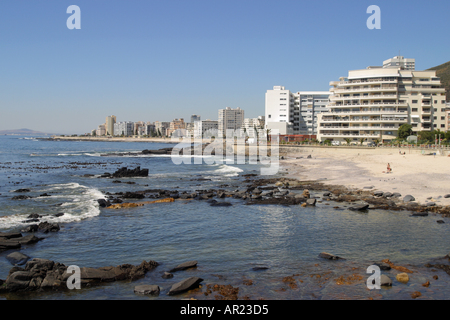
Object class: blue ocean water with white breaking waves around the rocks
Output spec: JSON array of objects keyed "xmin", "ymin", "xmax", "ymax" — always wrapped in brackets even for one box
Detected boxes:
[{"xmin": 0, "ymin": 136, "xmax": 450, "ymax": 300}]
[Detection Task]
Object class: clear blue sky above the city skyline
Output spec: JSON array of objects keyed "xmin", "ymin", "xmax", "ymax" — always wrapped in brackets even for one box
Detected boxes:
[{"xmin": 0, "ymin": 0, "xmax": 450, "ymax": 133}]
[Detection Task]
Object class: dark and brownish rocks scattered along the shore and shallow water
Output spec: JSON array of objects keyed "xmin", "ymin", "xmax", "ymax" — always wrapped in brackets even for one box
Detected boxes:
[{"xmin": 0, "ymin": 160, "xmax": 450, "ymax": 299}]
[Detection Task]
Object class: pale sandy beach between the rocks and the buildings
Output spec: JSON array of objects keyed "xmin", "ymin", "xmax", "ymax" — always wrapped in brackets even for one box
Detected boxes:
[{"xmin": 281, "ymin": 148, "xmax": 450, "ymax": 206}]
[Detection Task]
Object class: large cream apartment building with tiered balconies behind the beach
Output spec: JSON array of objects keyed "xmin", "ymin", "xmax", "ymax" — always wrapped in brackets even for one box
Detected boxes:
[{"xmin": 318, "ymin": 58, "xmax": 445, "ymax": 143}]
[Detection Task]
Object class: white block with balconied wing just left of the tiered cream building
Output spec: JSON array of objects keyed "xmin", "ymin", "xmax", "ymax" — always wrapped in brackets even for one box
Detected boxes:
[{"xmin": 265, "ymin": 86, "xmax": 330, "ymax": 136}]
